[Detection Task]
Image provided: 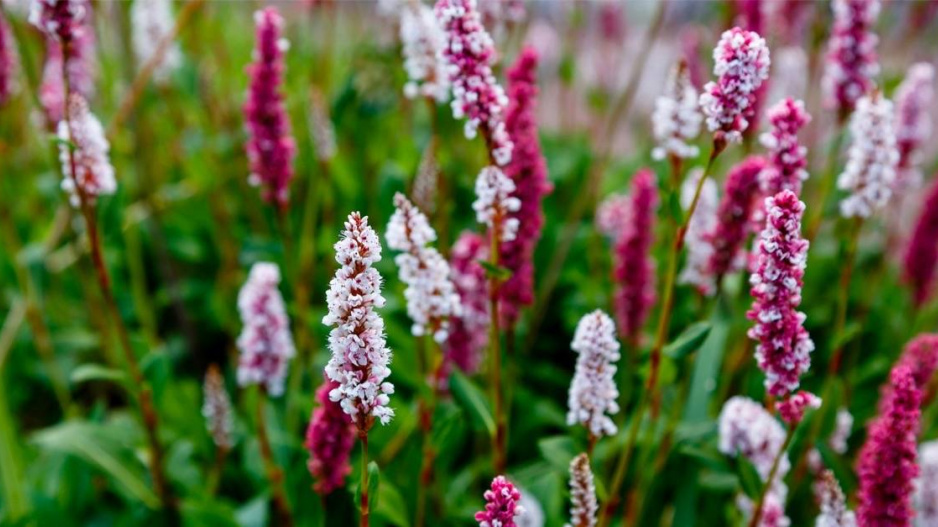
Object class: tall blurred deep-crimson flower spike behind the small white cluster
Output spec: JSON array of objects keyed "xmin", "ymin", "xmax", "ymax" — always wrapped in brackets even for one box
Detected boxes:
[{"xmin": 498, "ymin": 47, "xmax": 552, "ymax": 322}]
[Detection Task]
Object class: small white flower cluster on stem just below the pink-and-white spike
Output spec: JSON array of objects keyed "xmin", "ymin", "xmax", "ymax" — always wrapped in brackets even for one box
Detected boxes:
[{"xmin": 472, "ymin": 166, "xmax": 521, "ymax": 243}]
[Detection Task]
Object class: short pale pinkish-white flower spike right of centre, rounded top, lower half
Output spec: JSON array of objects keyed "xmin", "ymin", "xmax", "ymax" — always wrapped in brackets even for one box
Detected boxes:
[{"xmin": 567, "ymin": 310, "xmax": 619, "ymax": 438}]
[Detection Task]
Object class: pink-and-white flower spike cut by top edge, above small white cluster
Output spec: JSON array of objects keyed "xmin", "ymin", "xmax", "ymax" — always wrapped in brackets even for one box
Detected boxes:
[{"xmin": 435, "ymin": 0, "xmax": 514, "ymax": 166}]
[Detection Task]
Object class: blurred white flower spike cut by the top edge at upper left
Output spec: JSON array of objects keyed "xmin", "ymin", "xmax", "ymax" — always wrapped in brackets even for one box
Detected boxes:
[{"xmin": 130, "ymin": 0, "xmax": 182, "ymax": 83}]
